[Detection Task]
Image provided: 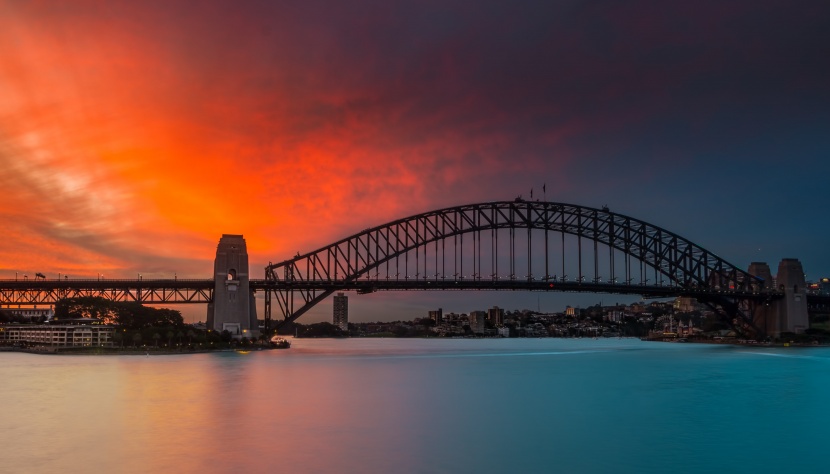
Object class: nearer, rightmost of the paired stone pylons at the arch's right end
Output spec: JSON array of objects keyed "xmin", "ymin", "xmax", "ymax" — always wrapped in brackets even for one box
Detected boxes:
[{"xmin": 776, "ymin": 258, "xmax": 810, "ymax": 333}]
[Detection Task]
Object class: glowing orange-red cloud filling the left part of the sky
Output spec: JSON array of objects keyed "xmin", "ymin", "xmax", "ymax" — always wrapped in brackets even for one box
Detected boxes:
[{"xmin": 0, "ymin": 2, "xmax": 580, "ymax": 277}]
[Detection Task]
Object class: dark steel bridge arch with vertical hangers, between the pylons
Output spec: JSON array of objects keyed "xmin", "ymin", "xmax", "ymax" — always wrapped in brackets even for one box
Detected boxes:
[{"xmin": 263, "ymin": 199, "xmax": 781, "ymax": 332}]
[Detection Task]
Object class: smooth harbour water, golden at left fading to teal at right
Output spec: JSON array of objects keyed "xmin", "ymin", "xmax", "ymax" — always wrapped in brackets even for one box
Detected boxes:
[{"xmin": 0, "ymin": 339, "xmax": 830, "ymax": 473}]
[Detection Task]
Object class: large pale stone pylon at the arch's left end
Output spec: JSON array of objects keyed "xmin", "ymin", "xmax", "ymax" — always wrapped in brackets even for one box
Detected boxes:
[{"xmin": 207, "ymin": 234, "xmax": 259, "ymax": 339}]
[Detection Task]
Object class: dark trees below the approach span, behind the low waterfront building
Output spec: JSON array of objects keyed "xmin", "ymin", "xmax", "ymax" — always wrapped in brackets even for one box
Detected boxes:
[{"xmin": 55, "ymin": 296, "xmax": 184, "ymax": 329}]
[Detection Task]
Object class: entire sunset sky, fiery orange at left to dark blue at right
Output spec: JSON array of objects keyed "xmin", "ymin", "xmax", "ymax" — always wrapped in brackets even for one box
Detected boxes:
[{"xmin": 0, "ymin": 0, "xmax": 830, "ymax": 319}]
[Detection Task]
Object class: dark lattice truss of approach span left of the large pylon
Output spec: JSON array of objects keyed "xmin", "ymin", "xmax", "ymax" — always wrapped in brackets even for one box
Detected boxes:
[{"xmin": 0, "ymin": 280, "xmax": 214, "ymax": 305}]
